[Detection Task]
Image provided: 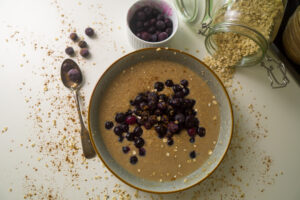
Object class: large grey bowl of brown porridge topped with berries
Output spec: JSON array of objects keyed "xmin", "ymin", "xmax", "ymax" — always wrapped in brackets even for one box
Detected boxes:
[{"xmin": 88, "ymin": 48, "xmax": 233, "ymax": 193}]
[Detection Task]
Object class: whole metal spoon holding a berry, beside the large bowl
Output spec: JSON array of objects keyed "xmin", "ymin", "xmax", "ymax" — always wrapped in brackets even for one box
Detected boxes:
[{"xmin": 60, "ymin": 59, "xmax": 96, "ymax": 158}]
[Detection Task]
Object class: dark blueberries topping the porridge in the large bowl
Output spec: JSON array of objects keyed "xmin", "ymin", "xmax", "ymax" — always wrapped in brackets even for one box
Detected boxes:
[{"xmin": 105, "ymin": 80, "xmax": 205, "ymax": 164}]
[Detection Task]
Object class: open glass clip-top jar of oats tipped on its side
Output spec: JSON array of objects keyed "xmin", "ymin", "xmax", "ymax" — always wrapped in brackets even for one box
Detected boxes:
[{"xmin": 174, "ymin": 0, "xmax": 288, "ymax": 86}]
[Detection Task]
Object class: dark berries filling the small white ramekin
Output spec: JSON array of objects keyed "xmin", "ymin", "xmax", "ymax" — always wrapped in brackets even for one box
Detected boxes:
[{"xmin": 130, "ymin": 6, "xmax": 173, "ymax": 42}]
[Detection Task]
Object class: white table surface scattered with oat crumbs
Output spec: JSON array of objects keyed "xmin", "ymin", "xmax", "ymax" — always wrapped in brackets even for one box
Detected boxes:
[{"xmin": 0, "ymin": 0, "xmax": 300, "ymax": 200}]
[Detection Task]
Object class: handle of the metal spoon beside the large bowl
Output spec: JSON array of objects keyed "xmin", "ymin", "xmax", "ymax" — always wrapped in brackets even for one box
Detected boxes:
[{"xmin": 73, "ymin": 90, "xmax": 96, "ymax": 158}]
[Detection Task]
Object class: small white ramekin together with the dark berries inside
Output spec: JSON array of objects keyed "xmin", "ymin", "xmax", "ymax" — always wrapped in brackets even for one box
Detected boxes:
[{"xmin": 127, "ymin": 0, "xmax": 178, "ymax": 49}]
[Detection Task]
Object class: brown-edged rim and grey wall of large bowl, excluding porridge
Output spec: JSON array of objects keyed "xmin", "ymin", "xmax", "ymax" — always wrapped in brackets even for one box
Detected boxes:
[{"xmin": 88, "ymin": 48, "xmax": 233, "ymax": 193}]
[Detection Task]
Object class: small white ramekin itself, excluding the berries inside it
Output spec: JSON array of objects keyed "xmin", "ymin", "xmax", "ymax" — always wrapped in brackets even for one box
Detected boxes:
[{"xmin": 127, "ymin": 0, "xmax": 178, "ymax": 49}]
